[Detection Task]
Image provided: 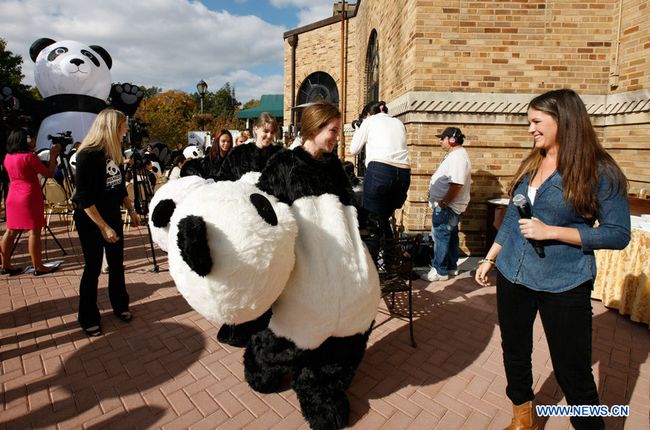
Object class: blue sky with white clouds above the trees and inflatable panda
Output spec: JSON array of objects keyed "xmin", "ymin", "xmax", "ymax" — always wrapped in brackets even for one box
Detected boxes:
[{"xmin": 0, "ymin": 0, "xmax": 334, "ymax": 102}]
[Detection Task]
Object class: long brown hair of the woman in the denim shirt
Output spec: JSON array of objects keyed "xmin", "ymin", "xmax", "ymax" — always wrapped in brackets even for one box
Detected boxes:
[{"xmin": 508, "ymin": 89, "xmax": 627, "ymax": 217}]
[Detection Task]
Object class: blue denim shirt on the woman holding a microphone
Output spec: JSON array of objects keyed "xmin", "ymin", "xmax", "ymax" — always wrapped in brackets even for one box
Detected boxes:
[{"xmin": 495, "ymin": 170, "xmax": 630, "ymax": 293}]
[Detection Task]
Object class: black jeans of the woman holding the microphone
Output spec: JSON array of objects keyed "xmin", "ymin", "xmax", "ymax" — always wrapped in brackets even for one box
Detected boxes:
[{"xmin": 497, "ymin": 272, "xmax": 604, "ymax": 429}]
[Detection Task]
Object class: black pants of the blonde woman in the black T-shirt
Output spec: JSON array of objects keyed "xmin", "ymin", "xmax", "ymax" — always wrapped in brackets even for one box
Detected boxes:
[{"xmin": 74, "ymin": 209, "xmax": 129, "ymax": 328}]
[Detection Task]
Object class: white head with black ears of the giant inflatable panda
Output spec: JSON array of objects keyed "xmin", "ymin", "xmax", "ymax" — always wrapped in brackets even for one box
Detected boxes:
[{"xmin": 29, "ymin": 38, "xmax": 112, "ymax": 100}]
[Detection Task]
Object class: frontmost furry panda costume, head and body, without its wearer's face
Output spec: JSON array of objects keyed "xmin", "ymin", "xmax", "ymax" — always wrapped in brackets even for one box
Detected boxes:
[{"xmin": 158, "ymin": 148, "xmax": 380, "ymax": 429}]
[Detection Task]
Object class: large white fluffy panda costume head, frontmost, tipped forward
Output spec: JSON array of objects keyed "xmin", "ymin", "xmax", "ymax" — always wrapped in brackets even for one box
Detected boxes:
[{"xmin": 168, "ymin": 181, "xmax": 297, "ymax": 324}]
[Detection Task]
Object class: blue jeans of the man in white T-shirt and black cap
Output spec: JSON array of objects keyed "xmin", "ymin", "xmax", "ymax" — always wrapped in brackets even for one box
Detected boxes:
[{"xmin": 431, "ymin": 207, "xmax": 460, "ymax": 276}]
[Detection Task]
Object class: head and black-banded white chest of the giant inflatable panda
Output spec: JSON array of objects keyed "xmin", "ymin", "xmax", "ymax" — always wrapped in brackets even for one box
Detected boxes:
[{"xmin": 29, "ymin": 38, "xmax": 113, "ymax": 149}]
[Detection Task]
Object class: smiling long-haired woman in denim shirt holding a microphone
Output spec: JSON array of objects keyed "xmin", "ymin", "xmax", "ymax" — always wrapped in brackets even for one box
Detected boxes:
[{"xmin": 476, "ymin": 89, "xmax": 630, "ymax": 429}]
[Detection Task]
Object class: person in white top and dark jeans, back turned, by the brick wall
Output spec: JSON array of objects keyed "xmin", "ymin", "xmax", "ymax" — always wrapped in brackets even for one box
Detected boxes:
[{"xmin": 350, "ymin": 101, "xmax": 411, "ymax": 258}]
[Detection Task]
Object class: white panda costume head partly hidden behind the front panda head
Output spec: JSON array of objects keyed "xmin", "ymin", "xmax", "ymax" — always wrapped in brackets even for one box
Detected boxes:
[{"xmin": 149, "ymin": 175, "xmax": 213, "ymax": 251}]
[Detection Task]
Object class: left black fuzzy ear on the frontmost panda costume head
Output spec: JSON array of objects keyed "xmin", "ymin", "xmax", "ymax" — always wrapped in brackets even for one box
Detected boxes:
[{"xmin": 177, "ymin": 215, "xmax": 212, "ymax": 277}]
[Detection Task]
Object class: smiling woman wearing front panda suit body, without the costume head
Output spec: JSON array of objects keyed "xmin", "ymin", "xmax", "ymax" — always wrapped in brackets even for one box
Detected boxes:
[{"xmin": 244, "ymin": 102, "xmax": 379, "ymax": 429}]
